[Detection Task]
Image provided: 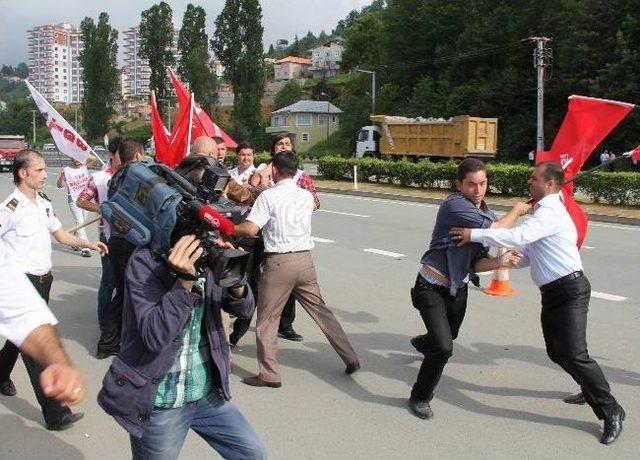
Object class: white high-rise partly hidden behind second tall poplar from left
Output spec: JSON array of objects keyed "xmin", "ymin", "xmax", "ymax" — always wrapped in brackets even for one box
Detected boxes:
[{"xmin": 122, "ymin": 26, "xmax": 180, "ymax": 98}]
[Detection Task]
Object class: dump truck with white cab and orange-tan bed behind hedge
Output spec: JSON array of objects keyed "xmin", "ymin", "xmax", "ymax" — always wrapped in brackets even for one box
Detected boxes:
[{"xmin": 356, "ymin": 115, "xmax": 498, "ymax": 159}]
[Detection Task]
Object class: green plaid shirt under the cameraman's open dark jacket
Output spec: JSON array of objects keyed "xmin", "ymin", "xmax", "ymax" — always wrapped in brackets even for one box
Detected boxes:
[{"xmin": 155, "ymin": 278, "xmax": 213, "ymax": 409}]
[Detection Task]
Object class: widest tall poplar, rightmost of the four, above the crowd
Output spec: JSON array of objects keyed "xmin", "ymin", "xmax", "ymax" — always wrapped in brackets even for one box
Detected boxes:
[{"xmin": 211, "ymin": 0, "xmax": 265, "ymax": 141}]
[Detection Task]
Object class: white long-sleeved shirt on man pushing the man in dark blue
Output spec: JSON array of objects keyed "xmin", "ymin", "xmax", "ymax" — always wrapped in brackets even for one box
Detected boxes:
[{"xmin": 471, "ymin": 193, "xmax": 582, "ymax": 286}]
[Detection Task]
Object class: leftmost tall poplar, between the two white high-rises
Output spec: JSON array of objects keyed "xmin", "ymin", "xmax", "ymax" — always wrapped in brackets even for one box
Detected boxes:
[{"xmin": 79, "ymin": 13, "xmax": 120, "ymax": 140}]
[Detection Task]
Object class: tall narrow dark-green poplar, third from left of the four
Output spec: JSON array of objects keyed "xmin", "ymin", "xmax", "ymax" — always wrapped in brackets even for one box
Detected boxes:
[{"xmin": 178, "ymin": 4, "xmax": 217, "ymax": 113}]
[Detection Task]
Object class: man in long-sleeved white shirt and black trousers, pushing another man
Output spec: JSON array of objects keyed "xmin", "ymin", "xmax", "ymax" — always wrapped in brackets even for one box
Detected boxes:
[{"xmin": 451, "ymin": 162, "xmax": 625, "ymax": 444}]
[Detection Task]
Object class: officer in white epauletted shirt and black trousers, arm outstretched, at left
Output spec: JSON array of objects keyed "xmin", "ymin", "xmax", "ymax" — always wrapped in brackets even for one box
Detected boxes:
[{"xmin": 0, "ymin": 150, "xmax": 107, "ymax": 431}]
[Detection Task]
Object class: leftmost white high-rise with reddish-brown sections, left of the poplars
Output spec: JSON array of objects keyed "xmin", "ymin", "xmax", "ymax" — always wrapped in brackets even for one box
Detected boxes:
[{"xmin": 27, "ymin": 23, "xmax": 84, "ymax": 104}]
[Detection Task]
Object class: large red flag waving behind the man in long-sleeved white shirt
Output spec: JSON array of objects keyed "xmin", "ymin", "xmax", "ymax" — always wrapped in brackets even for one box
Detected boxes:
[{"xmin": 536, "ymin": 96, "xmax": 635, "ymax": 248}]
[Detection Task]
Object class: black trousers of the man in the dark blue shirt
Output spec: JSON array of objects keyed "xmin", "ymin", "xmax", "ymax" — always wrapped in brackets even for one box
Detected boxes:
[{"xmin": 411, "ymin": 275, "xmax": 468, "ymax": 401}]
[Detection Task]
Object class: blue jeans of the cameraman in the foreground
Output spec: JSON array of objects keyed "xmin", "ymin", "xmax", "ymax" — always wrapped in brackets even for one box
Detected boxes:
[{"xmin": 130, "ymin": 391, "xmax": 267, "ymax": 460}]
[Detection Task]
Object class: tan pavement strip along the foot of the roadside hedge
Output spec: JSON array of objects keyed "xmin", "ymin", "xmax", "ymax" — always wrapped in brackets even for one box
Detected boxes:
[{"xmin": 313, "ymin": 176, "xmax": 640, "ymax": 225}]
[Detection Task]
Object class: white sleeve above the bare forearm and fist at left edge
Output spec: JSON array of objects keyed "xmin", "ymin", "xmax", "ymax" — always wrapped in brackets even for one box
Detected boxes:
[{"xmin": 0, "ymin": 252, "xmax": 58, "ymax": 347}]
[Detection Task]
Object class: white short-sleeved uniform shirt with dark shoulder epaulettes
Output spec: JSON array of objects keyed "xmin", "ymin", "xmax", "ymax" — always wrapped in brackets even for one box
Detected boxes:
[{"xmin": 0, "ymin": 188, "xmax": 62, "ymax": 276}]
